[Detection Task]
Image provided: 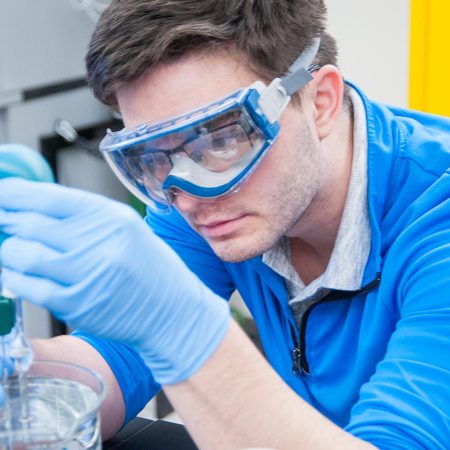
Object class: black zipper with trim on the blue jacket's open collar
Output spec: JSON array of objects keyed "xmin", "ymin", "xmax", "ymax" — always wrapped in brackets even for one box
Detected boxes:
[{"xmin": 291, "ymin": 273, "xmax": 381, "ymax": 375}]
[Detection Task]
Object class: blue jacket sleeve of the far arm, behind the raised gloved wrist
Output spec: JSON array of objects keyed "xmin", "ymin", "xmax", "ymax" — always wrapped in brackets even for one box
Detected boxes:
[{"xmin": 73, "ymin": 207, "xmax": 234, "ymax": 424}]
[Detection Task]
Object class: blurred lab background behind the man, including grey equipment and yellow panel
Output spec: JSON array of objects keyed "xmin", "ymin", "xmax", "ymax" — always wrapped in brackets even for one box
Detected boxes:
[{"xmin": 0, "ymin": 0, "xmax": 450, "ymax": 415}]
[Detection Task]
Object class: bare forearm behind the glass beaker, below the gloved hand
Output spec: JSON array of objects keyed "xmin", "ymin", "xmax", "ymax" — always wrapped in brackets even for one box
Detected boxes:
[{"xmin": 32, "ymin": 336, "xmax": 125, "ymax": 439}]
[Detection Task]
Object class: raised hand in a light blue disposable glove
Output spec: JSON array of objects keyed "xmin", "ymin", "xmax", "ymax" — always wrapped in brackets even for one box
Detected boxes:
[{"xmin": 0, "ymin": 178, "xmax": 230, "ymax": 384}]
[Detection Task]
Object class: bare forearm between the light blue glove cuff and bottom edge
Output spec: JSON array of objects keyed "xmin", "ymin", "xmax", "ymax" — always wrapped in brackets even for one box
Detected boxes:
[{"xmin": 164, "ymin": 322, "xmax": 375, "ymax": 450}]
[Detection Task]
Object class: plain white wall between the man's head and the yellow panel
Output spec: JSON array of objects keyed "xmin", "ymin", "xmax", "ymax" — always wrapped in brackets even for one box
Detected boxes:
[{"xmin": 326, "ymin": 0, "xmax": 410, "ymax": 106}]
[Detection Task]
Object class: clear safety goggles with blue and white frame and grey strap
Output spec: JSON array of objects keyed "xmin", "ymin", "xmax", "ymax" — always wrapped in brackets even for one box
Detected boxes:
[{"xmin": 100, "ymin": 38, "xmax": 320, "ymax": 213}]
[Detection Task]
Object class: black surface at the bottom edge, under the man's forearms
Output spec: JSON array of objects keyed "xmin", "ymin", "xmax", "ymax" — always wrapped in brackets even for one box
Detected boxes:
[{"xmin": 103, "ymin": 417, "xmax": 198, "ymax": 450}]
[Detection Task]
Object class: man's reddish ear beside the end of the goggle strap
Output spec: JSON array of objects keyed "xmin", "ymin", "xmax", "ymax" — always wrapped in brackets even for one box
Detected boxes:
[{"xmin": 307, "ymin": 64, "xmax": 344, "ymax": 140}]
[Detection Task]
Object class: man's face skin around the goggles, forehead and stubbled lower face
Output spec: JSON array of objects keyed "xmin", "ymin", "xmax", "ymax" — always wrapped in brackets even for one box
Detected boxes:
[{"xmin": 117, "ymin": 53, "xmax": 323, "ymax": 262}]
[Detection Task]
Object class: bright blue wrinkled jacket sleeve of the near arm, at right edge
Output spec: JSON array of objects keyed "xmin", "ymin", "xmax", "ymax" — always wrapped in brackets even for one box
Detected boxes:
[{"xmin": 346, "ymin": 175, "xmax": 450, "ymax": 450}]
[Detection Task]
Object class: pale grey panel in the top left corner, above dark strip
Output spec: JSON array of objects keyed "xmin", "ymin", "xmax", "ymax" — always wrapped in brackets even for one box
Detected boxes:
[{"xmin": 0, "ymin": 0, "xmax": 94, "ymax": 96}]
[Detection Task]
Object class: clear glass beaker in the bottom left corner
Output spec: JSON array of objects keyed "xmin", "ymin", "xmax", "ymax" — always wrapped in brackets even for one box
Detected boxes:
[{"xmin": 0, "ymin": 361, "xmax": 105, "ymax": 450}]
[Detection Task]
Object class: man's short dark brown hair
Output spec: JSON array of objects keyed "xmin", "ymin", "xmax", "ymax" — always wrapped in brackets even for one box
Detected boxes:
[{"xmin": 86, "ymin": 0, "xmax": 337, "ymax": 107}]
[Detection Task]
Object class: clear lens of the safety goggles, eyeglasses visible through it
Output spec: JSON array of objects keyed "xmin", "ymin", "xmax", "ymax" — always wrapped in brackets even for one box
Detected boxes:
[{"xmin": 105, "ymin": 109, "xmax": 266, "ymax": 206}]
